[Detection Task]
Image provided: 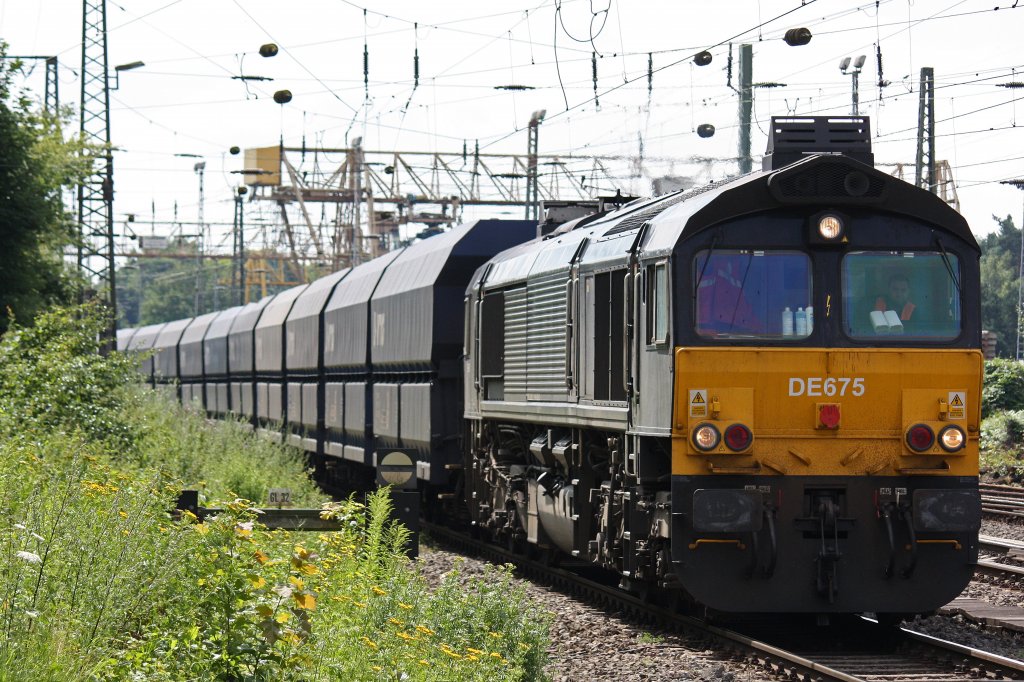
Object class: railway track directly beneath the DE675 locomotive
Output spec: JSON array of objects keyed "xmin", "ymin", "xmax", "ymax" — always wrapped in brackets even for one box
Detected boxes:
[{"xmin": 425, "ymin": 524, "xmax": 1024, "ymax": 682}]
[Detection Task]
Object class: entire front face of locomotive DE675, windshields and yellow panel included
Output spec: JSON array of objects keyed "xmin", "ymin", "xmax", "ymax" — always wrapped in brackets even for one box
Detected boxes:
[{"xmin": 672, "ymin": 116, "xmax": 982, "ymax": 614}]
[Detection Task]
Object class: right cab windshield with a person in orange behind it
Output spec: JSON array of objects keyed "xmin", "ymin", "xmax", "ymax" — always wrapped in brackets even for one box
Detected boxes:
[{"xmin": 843, "ymin": 251, "xmax": 961, "ymax": 341}]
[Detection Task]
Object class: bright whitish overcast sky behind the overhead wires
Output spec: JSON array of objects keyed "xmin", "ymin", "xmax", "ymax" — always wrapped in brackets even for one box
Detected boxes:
[{"xmin": 0, "ymin": 0, "xmax": 1024, "ymax": 256}]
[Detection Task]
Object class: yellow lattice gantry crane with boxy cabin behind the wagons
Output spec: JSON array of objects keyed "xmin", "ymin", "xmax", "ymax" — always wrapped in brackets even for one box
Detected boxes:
[{"xmin": 245, "ymin": 144, "xmax": 629, "ymax": 268}]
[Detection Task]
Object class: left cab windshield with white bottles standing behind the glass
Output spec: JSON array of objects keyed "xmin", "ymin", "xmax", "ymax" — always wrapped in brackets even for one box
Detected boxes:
[{"xmin": 693, "ymin": 249, "xmax": 814, "ymax": 341}]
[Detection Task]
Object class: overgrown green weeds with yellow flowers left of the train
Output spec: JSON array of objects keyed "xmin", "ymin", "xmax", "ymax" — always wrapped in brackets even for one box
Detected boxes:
[{"xmin": 0, "ymin": 308, "xmax": 548, "ymax": 681}]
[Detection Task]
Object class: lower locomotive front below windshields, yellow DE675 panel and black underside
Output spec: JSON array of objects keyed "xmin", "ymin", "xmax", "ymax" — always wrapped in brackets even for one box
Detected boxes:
[{"xmin": 672, "ymin": 348, "xmax": 982, "ymax": 613}]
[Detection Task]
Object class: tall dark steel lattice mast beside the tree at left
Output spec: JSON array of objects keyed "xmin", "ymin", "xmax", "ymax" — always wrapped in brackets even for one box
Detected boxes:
[{"xmin": 78, "ymin": 0, "xmax": 118, "ymax": 347}]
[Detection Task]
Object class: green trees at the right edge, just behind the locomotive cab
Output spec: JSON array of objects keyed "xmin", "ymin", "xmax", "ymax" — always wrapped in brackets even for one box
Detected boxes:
[{"xmin": 981, "ymin": 215, "xmax": 1021, "ymax": 357}]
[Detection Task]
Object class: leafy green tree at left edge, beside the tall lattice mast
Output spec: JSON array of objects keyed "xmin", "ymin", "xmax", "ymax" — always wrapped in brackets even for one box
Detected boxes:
[{"xmin": 0, "ymin": 41, "xmax": 85, "ymax": 333}]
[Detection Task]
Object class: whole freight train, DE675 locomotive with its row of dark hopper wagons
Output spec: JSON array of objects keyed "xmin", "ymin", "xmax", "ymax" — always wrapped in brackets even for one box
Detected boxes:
[{"xmin": 119, "ymin": 117, "xmax": 982, "ymax": 616}]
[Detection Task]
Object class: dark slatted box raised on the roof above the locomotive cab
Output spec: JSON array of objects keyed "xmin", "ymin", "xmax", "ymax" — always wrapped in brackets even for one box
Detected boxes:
[{"xmin": 762, "ymin": 116, "xmax": 874, "ymax": 171}]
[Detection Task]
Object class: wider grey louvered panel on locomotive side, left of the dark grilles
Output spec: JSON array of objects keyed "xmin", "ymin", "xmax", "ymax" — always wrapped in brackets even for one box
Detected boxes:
[{"xmin": 526, "ymin": 273, "xmax": 568, "ymax": 400}]
